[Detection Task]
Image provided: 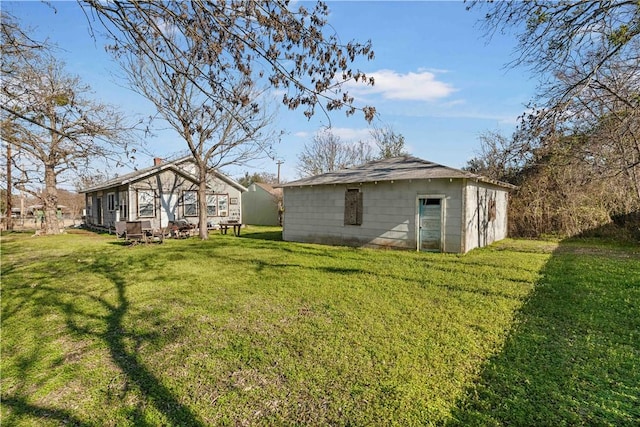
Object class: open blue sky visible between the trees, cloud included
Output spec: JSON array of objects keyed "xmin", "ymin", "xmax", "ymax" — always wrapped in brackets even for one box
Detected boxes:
[{"xmin": 2, "ymin": 1, "xmax": 536, "ymax": 181}]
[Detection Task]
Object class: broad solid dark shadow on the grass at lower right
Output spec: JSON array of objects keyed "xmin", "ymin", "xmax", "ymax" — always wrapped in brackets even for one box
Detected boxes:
[{"xmin": 447, "ymin": 242, "xmax": 640, "ymax": 426}]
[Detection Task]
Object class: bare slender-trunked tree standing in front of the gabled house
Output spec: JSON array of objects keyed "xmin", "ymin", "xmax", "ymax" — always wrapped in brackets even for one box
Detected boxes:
[{"xmin": 116, "ymin": 33, "xmax": 277, "ymax": 239}]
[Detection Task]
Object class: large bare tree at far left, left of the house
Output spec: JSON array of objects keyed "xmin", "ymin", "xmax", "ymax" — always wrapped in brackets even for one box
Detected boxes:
[{"xmin": 3, "ymin": 49, "xmax": 131, "ymax": 234}]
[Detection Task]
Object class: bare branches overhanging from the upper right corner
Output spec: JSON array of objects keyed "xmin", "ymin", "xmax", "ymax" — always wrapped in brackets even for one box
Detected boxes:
[{"xmin": 473, "ymin": 0, "xmax": 640, "ymax": 191}]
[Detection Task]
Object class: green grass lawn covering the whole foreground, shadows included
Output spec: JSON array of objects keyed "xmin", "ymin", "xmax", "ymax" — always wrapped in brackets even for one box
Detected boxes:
[{"xmin": 0, "ymin": 227, "xmax": 640, "ymax": 426}]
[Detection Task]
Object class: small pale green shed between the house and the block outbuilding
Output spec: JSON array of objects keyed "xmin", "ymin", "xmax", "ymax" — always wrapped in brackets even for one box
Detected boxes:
[{"xmin": 242, "ymin": 182, "xmax": 282, "ymax": 225}]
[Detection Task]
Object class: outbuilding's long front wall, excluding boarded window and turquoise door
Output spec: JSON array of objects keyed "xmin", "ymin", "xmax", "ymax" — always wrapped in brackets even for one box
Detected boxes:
[{"xmin": 283, "ymin": 179, "xmax": 463, "ymax": 252}]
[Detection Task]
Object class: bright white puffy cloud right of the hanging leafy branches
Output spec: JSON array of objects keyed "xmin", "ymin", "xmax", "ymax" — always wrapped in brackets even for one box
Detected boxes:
[{"xmin": 352, "ymin": 70, "xmax": 456, "ymax": 101}]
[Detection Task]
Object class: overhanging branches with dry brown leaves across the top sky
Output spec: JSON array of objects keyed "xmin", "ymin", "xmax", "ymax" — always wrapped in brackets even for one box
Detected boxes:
[{"xmin": 80, "ymin": 0, "xmax": 375, "ymax": 121}]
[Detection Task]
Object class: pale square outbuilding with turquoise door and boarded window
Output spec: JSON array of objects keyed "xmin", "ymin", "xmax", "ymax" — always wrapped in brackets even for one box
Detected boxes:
[{"xmin": 281, "ymin": 156, "xmax": 516, "ymax": 253}]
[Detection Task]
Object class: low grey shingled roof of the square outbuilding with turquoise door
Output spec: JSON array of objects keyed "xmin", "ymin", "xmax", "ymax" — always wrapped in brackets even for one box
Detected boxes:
[{"xmin": 280, "ymin": 156, "xmax": 516, "ymax": 189}]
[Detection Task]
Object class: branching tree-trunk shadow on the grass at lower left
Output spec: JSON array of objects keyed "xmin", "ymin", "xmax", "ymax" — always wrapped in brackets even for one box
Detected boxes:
[{"xmin": 2, "ymin": 251, "xmax": 204, "ymax": 426}]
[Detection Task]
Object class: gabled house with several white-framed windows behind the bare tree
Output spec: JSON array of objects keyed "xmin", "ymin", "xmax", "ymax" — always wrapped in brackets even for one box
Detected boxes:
[{"xmin": 81, "ymin": 157, "xmax": 247, "ymax": 229}]
